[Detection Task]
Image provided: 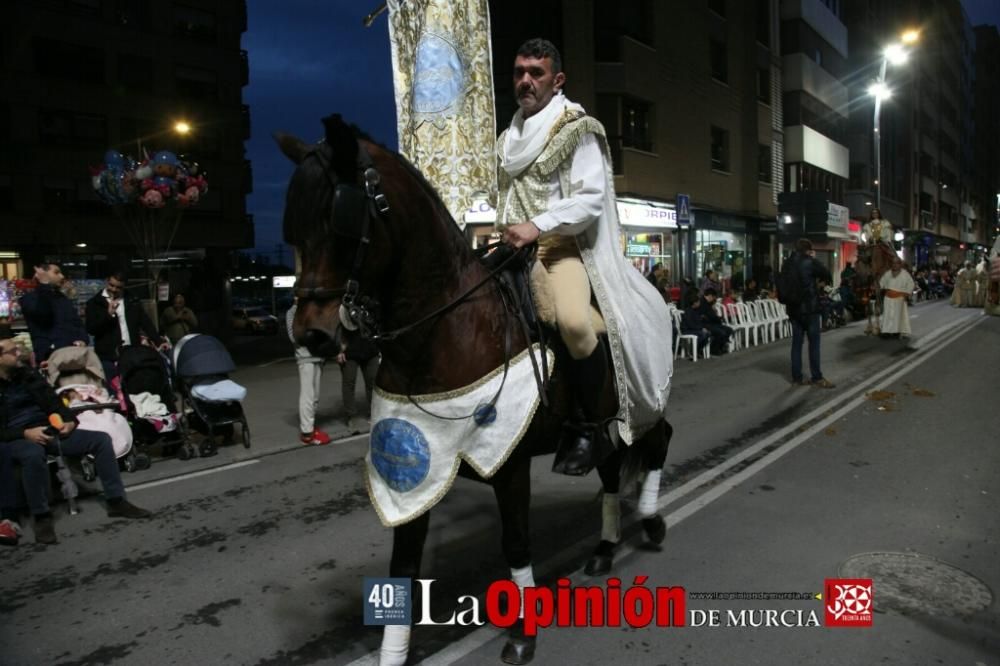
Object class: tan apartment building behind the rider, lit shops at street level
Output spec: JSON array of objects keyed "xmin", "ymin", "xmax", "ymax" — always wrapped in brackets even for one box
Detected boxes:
[{"xmin": 491, "ymin": 0, "xmax": 785, "ymax": 288}]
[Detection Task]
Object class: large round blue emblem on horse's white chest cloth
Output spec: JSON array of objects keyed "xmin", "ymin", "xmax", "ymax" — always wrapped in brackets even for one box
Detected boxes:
[{"xmin": 370, "ymin": 418, "xmax": 431, "ymax": 493}]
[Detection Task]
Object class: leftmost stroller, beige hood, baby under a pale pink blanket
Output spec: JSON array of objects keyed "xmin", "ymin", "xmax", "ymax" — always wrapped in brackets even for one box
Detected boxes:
[{"xmin": 44, "ymin": 347, "xmax": 150, "ymax": 472}]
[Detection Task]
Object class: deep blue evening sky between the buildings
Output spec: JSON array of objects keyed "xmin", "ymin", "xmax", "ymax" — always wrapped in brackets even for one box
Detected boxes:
[{"xmin": 243, "ymin": 0, "xmax": 1000, "ymax": 262}]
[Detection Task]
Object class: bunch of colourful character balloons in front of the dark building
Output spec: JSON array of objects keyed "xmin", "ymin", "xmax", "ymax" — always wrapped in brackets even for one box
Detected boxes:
[{"xmin": 91, "ymin": 150, "xmax": 208, "ymax": 208}]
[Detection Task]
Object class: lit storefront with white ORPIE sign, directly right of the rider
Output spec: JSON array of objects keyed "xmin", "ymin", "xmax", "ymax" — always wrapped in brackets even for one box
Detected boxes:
[{"xmin": 617, "ymin": 199, "xmax": 680, "ymax": 283}]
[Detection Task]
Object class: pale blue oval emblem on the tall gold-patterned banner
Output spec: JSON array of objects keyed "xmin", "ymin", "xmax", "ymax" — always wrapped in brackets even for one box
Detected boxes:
[{"xmin": 413, "ymin": 33, "xmax": 465, "ymax": 114}]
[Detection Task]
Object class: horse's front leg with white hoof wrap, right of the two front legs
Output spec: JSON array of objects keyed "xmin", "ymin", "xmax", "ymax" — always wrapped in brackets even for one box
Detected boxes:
[{"xmin": 493, "ymin": 450, "xmax": 537, "ymax": 664}]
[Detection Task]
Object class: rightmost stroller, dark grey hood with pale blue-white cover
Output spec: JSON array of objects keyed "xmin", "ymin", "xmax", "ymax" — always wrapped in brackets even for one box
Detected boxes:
[{"xmin": 174, "ymin": 333, "xmax": 250, "ymax": 457}]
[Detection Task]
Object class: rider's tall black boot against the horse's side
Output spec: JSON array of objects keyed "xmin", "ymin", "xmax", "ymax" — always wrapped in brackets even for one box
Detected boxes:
[{"xmin": 552, "ymin": 343, "xmax": 614, "ymax": 476}]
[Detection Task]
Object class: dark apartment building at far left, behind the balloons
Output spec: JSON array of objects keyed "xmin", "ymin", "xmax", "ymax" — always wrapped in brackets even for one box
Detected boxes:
[{"xmin": 0, "ymin": 0, "xmax": 253, "ymax": 290}]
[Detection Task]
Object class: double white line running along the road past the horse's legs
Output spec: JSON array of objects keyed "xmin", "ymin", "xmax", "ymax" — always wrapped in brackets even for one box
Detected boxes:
[{"xmin": 390, "ymin": 312, "xmax": 983, "ymax": 666}]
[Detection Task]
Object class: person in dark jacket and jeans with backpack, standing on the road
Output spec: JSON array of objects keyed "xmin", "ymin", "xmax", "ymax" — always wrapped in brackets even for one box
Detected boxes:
[{"xmin": 777, "ymin": 238, "xmax": 834, "ymax": 388}]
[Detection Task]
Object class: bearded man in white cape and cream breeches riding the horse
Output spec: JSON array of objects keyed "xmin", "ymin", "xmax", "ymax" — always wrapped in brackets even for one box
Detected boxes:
[{"xmin": 497, "ymin": 39, "xmax": 673, "ymax": 474}]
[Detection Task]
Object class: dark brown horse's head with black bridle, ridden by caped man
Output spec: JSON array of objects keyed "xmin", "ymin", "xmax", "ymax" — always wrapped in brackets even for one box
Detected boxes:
[{"xmin": 275, "ymin": 115, "xmax": 392, "ymax": 355}]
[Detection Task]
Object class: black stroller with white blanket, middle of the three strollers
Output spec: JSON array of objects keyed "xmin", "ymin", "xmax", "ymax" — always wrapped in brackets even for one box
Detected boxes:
[{"xmin": 112, "ymin": 345, "xmax": 198, "ymax": 451}]
